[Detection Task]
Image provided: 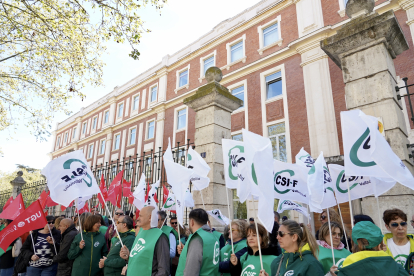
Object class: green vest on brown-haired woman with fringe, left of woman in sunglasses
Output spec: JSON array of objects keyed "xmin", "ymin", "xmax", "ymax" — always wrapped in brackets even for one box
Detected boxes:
[{"xmin": 240, "ymin": 252, "xmax": 277, "ymax": 276}]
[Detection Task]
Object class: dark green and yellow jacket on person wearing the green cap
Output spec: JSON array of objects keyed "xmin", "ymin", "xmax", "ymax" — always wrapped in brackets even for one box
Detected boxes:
[{"xmin": 338, "ymin": 251, "xmax": 408, "ymax": 276}]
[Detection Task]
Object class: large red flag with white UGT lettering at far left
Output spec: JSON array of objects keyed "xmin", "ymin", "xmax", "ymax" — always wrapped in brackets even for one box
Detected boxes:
[{"xmin": 0, "ymin": 200, "xmax": 47, "ymax": 252}]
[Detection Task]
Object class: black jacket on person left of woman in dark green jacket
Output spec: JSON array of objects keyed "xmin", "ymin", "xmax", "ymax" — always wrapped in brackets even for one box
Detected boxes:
[{"xmin": 53, "ymin": 224, "xmax": 78, "ymax": 276}]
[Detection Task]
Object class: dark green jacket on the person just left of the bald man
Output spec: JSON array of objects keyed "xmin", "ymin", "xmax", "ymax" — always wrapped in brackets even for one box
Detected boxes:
[{"xmin": 104, "ymin": 230, "xmax": 135, "ymax": 276}]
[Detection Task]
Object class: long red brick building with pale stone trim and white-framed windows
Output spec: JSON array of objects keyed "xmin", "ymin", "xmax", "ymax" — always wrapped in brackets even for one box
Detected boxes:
[{"xmin": 50, "ymin": 0, "xmax": 414, "ymax": 227}]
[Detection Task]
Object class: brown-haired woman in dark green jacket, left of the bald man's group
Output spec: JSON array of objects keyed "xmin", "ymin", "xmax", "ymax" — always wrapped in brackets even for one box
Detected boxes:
[{"xmin": 68, "ymin": 215, "xmax": 108, "ymax": 276}]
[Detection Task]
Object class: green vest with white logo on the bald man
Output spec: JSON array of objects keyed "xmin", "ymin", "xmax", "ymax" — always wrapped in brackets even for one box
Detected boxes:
[{"xmin": 127, "ymin": 228, "xmax": 163, "ymax": 276}]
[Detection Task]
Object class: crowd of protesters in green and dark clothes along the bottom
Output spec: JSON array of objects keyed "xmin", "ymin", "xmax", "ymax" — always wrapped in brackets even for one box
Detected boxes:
[{"xmin": 0, "ymin": 206, "xmax": 414, "ymax": 276}]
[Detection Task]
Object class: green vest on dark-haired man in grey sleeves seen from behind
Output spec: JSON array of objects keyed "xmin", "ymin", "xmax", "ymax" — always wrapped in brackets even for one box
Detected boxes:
[{"xmin": 176, "ymin": 228, "xmax": 220, "ymax": 276}]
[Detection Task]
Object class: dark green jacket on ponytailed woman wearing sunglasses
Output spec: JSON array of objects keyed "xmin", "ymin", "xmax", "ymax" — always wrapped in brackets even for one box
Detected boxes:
[{"xmin": 271, "ymin": 244, "xmax": 325, "ymax": 276}]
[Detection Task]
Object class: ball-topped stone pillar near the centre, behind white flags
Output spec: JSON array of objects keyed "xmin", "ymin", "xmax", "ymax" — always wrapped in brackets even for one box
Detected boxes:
[{"xmin": 184, "ymin": 67, "xmax": 243, "ymax": 229}]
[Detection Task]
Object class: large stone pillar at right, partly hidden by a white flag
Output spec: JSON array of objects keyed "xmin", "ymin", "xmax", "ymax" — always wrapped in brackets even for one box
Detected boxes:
[{"xmin": 321, "ymin": 0, "xmax": 414, "ymax": 231}]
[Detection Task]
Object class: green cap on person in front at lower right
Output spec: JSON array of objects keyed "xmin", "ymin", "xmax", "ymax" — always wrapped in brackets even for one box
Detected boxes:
[{"xmin": 352, "ymin": 221, "xmax": 384, "ymax": 249}]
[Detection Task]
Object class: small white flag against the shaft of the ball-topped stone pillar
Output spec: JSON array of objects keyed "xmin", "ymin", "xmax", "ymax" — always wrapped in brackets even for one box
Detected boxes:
[{"xmin": 187, "ymin": 147, "xmax": 210, "ymax": 191}]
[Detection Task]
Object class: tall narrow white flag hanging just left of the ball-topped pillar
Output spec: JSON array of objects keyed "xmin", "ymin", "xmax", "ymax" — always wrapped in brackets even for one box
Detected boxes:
[{"xmin": 164, "ymin": 138, "xmax": 193, "ymax": 225}]
